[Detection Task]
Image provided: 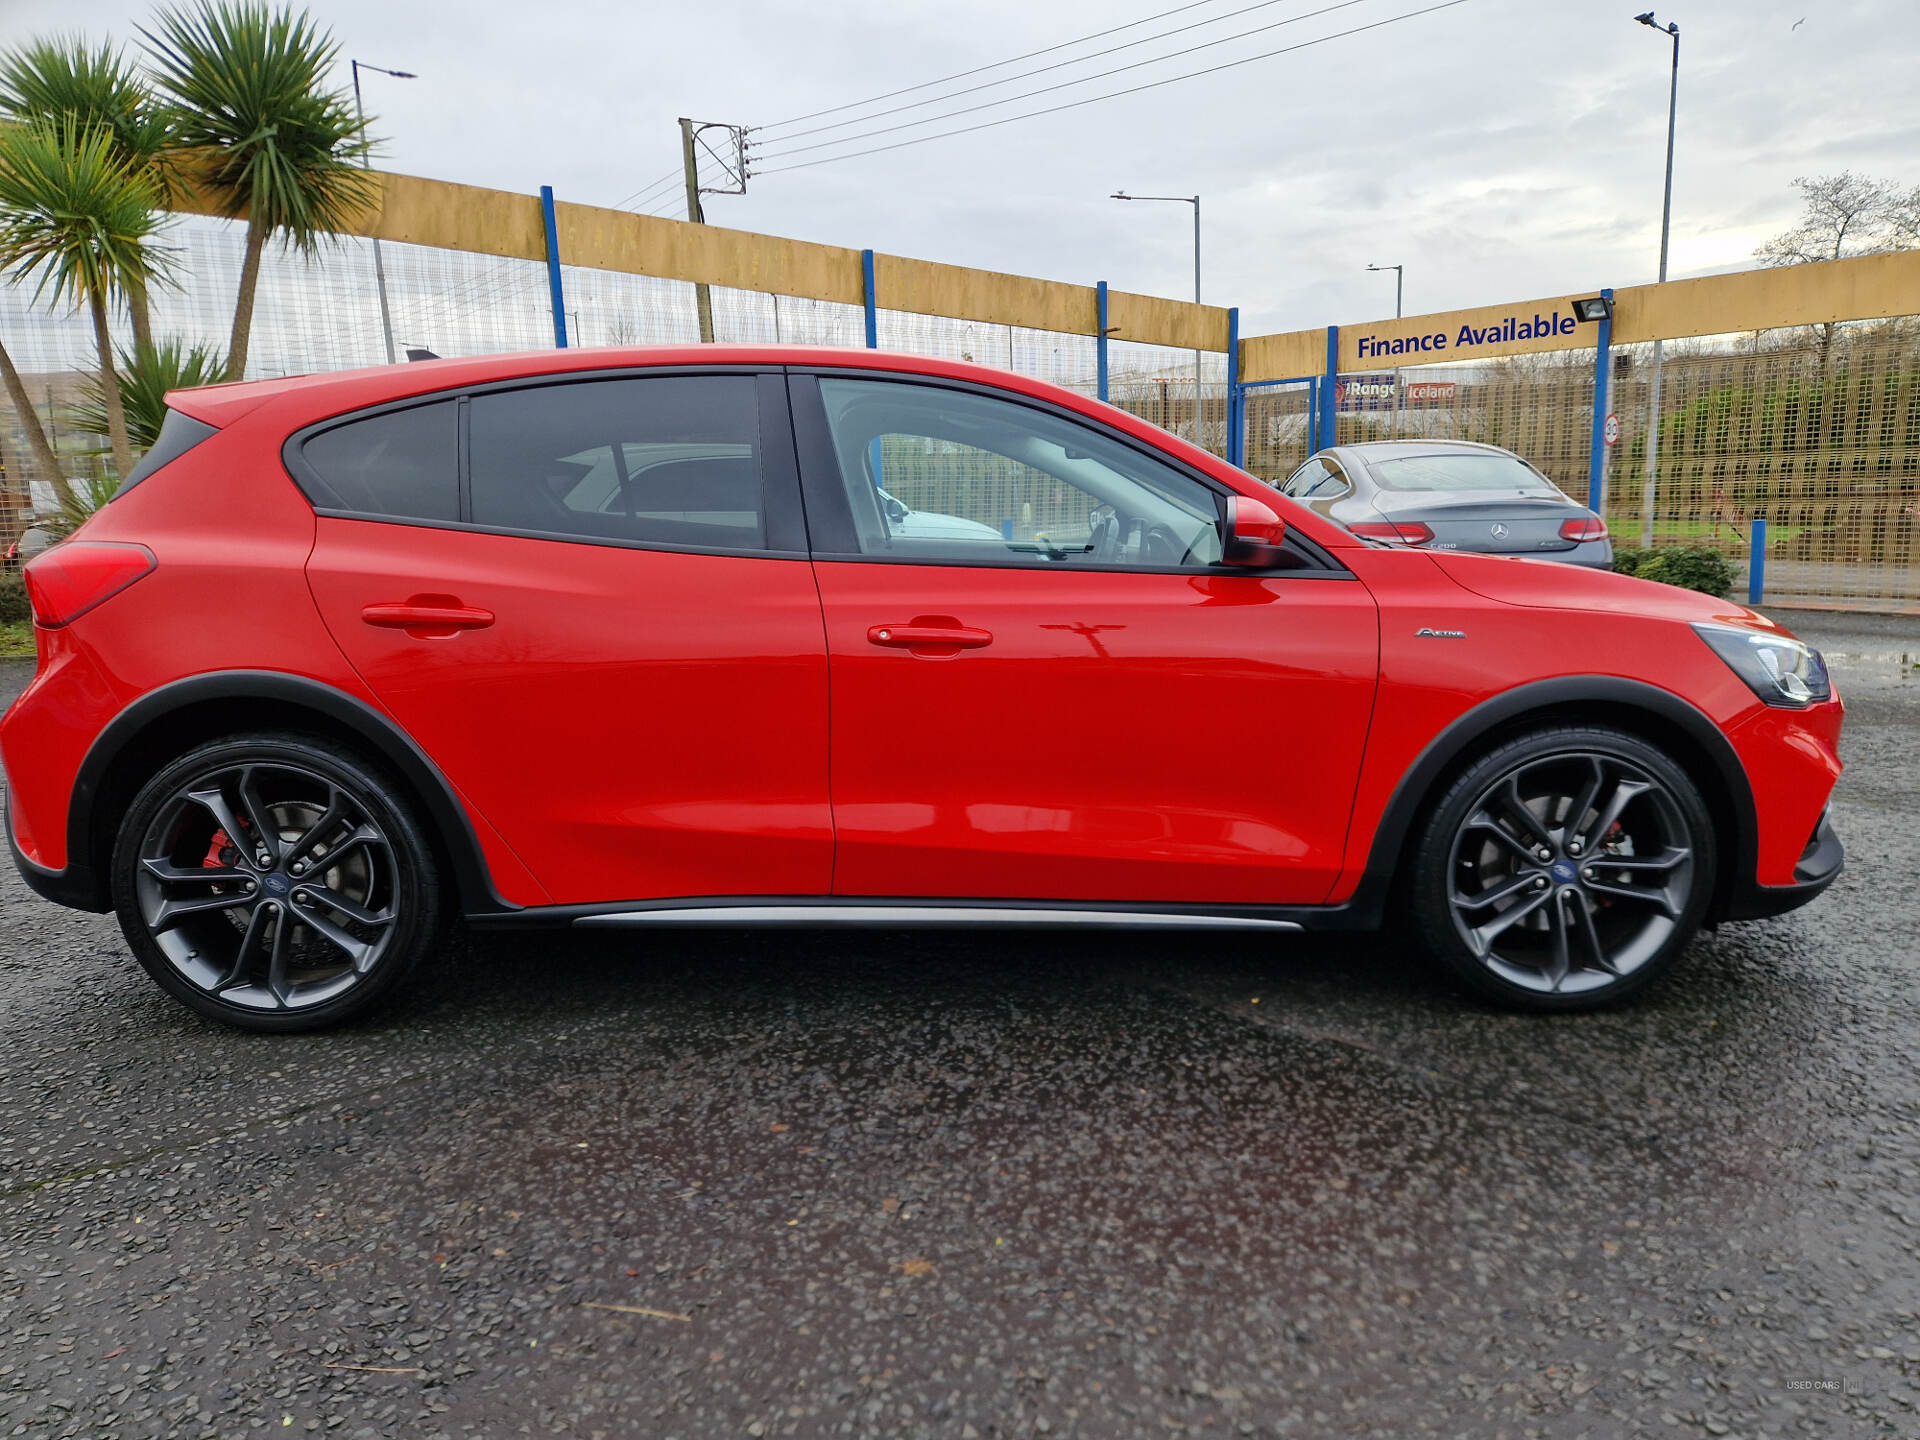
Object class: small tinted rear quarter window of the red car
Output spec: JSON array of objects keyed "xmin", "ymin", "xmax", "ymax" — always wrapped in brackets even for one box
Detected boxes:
[{"xmin": 300, "ymin": 399, "xmax": 461, "ymax": 520}]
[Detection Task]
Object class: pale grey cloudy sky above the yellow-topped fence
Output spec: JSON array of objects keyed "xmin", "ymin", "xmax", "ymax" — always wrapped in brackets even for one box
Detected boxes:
[{"xmin": 0, "ymin": 0, "xmax": 1920, "ymax": 334}]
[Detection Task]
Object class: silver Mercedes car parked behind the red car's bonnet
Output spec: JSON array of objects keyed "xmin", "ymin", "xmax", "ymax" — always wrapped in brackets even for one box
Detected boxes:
[{"xmin": 1279, "ymin": 440, "xmax": 1613, "ymax": 570}]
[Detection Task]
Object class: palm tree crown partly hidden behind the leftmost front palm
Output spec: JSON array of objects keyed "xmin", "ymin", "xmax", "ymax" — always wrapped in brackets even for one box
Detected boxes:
[{"xmin": 0, "ymin": 36, "xmax": 182, "ymax": 346}]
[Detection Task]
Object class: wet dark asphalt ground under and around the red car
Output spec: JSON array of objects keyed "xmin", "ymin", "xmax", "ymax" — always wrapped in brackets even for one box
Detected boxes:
[{"xmin": 0, "ymin": 614, "xmax": 1920, "ymax": 1440}]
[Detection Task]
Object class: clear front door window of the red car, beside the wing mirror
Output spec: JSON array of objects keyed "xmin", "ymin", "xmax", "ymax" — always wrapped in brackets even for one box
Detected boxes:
[{"xmin": 820, "ymin": 378, "xmax": 1219, "ymax": 568}]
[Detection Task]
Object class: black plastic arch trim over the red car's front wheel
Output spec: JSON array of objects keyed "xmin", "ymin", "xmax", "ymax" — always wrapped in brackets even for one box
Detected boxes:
[{"xmin": 1346, "ymin": 676, "xmax": 1759, "ymax": 922}]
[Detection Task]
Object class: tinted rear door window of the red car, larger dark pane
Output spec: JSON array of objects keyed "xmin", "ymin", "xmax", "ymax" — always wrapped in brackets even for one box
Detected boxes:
[{"xmin": 468, "ymin": 374, "xmax": 766, "ymax": 549}]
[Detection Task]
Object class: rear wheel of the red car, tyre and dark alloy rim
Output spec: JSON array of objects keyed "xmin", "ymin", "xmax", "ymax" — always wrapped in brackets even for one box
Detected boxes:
[{"xmin": 113, "ymin": 733, "xmax": 442, "ymax": 1031}]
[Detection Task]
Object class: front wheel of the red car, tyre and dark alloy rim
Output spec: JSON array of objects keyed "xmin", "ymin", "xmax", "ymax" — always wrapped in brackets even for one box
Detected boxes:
[{"xmin": 1411, "ymin": 726, "xmax": 1716, "ymax": 1010}]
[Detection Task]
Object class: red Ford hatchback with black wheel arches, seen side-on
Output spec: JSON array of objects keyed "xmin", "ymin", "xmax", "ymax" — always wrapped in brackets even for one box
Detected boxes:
[{"xmin": 0, "ymin": 346, "xmax": 1841, "ymax": 1031}]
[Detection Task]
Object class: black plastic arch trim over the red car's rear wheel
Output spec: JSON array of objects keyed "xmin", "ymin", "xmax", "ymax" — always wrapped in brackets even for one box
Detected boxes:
[{"xmin": 67, "ymin": 670, "xmax": 520, "ymax": 912}]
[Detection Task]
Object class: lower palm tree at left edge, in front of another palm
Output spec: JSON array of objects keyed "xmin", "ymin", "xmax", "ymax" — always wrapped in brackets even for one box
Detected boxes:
[{"xmin": 0, "ymin": 121, "xmax": 171, "ymax": 476}]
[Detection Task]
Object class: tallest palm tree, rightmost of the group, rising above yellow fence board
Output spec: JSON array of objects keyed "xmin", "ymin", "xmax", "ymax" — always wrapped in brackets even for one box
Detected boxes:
[{"xmin": 140, "ymin": 0, "xmax": 374, "ymax": 380}]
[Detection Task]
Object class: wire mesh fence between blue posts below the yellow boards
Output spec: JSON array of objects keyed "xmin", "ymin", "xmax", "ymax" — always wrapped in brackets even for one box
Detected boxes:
[{"xmin": 0, "ymin": 217, "xmax": 1920, "ymax": 605}]
